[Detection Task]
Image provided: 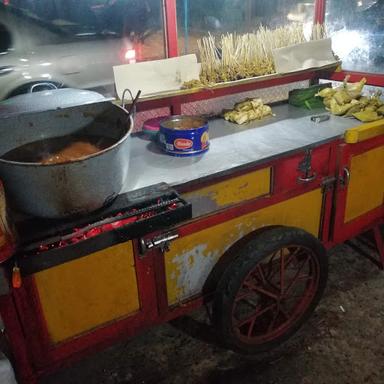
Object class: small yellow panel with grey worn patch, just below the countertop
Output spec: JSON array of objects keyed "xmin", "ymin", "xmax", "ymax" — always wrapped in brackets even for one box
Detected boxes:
[{"xmin": 183, "ymin": 168, "xmax": 271, "ymax": 208}]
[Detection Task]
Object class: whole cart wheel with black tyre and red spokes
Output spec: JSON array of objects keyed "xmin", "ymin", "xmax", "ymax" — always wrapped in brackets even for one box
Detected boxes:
[{"xmin": 213, "ymin": 227, "xmax": 328, "ymax": 353}]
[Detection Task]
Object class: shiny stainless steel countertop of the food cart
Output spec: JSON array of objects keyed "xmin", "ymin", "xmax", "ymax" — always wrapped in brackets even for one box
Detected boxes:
[{"xmin": 122, "ymin": 104, "xmax": 361, "ymax": 192}]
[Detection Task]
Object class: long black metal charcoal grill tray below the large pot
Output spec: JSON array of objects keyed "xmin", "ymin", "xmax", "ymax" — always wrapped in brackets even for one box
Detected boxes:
[{"xmin": 15, "ymin": 183, "xmax": 192, "ymax": 275}]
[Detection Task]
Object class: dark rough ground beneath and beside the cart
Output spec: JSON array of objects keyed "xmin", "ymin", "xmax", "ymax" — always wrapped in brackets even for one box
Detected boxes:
[{"xmin": 44, "ymin": 246, "xmax": 384, "ymax": 384}]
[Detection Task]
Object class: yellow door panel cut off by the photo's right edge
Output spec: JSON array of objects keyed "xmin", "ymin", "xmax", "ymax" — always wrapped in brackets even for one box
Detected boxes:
[{"xmin": 345, "ymin": 146, "xmax": 384, "ymax": 223}]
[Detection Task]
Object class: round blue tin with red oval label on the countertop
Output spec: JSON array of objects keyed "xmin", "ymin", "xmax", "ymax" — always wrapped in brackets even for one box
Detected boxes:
[{"xmin": 159, "ymin": 116, "xmax": 209, "ymax": 157}]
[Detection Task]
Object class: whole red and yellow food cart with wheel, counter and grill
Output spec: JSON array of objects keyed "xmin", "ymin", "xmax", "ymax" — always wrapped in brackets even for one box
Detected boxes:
[{"xmin": 0, "ymin": 1, "xmax": 384, "ymax": 383}]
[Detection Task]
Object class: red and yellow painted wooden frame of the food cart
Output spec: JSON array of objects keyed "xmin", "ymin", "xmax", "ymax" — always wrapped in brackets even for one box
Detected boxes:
[{"xmin": 0, "ymin": 0, "xmax": 384, "ymax": 383}]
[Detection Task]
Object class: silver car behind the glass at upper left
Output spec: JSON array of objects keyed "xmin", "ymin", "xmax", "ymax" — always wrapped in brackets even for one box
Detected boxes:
[{"xmin": 0, "ymin": 0, "xmax": 159, "ymax": 100}]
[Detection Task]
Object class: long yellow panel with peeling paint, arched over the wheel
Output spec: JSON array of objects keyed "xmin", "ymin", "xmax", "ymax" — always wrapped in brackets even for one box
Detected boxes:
[{"xmin": 165, "ymin": 189, "xmax": 322, "ymax": 305}]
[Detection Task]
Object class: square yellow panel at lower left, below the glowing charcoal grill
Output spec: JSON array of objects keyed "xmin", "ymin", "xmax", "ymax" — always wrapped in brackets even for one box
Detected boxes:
[{"xmin": 34, "ymin": 241, "xmax": 139, "ymax": 343}]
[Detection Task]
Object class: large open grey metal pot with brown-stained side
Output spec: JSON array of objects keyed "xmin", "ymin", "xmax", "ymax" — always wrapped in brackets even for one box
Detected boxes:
[{"xmin": 0, "ymin": 101, "xmax": 133, "ymax": 218}]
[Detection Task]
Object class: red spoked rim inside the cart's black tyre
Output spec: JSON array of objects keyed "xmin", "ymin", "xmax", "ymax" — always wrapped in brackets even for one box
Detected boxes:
[{"xmin": 232, "ymin": 245, "xmax": 320, "ymax": 345}]
